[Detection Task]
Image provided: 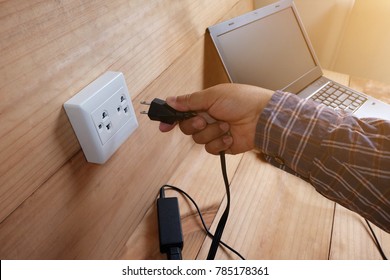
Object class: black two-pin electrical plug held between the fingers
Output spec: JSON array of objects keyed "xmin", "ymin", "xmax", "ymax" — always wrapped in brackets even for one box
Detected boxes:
[{"xmin": 141, "ymin": 98, "xmax": 197, "ymax": 124}]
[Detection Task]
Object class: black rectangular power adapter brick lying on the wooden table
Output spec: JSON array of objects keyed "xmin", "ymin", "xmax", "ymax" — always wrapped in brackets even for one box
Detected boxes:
[{"xmin": 157, "ymin": 189, "xmax": 183, "ymax": 260}]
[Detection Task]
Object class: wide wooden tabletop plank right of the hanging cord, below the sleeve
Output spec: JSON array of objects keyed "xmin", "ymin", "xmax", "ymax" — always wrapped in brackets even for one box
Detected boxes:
[{"xmin": 198, "ymin": 152, "xmax": 334, "ymax": 259}]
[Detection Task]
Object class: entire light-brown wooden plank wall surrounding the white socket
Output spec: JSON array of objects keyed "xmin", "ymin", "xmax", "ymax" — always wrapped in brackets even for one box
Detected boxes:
[{"xmin": 0, "ymin": 0, "xmax": 252, "ymax": 259}]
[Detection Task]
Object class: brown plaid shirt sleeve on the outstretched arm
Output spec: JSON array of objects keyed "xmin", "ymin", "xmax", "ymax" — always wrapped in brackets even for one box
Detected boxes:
[{"xmin": 255, "ymin": 91, "xmax": 390, "ymax": 232}]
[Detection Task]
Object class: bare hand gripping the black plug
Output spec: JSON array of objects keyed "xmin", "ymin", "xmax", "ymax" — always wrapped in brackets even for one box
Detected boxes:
[{"xmin": 160, "ymin": 84, "xmax": 273, "ymax": 154}]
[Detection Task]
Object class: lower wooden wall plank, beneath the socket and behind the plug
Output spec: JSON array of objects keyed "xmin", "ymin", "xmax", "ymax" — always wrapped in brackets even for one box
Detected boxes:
[{"xmin": 0, "ymin": 1, "xmax": 249, "ymax": 259}]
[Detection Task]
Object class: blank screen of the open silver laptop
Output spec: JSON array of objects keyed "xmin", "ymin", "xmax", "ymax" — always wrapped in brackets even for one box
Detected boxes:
[{"xmin": 210, "ymin": 3, "xmax": 319, "ymax": 90}]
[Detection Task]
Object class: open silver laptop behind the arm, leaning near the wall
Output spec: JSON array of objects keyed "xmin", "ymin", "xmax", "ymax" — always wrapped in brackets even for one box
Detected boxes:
[{"xmin": 208, "ymin": 0, "xmax": 390, "ymax": 120}]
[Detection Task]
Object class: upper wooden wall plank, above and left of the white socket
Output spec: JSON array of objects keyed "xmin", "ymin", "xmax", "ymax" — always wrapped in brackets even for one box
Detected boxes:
[{"xmin": 0, "ymin": 0, "xmax": 241, "ymax": 225}]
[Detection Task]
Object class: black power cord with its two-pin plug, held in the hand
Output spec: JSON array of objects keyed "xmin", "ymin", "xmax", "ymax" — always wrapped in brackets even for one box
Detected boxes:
[{"xmin": 141, "ymin": 98, "xmax": 238, "ymax": 260}]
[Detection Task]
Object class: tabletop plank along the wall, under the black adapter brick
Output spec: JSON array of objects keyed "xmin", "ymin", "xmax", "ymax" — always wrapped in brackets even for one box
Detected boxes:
[{"xmin": 119, "ymin": 145, "xmax": 242, "ymax": 259}]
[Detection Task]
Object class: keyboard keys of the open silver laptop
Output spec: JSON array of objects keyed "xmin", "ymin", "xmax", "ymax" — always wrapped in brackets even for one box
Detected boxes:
[{"xmin": 310, "ymin": 82, "xmax": 367, "ymax": 113}]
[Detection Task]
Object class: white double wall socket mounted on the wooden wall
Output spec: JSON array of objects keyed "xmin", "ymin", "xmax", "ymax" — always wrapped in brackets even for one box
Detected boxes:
[{"xmin": 64, "ymin": 72, "xmax": 138, "ymax": 164}]
